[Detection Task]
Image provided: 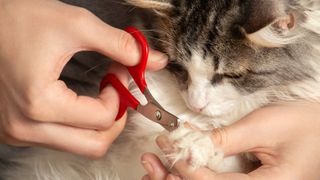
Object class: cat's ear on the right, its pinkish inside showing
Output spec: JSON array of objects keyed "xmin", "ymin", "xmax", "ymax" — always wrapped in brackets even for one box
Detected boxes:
[{"xmin": 242, "ymin": 0, "xmax": 296, "ymax": 47}]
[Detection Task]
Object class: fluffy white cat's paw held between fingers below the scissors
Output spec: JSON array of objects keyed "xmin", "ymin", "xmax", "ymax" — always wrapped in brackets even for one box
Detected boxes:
[{"xmin": 168, "ymin": 125, "xmax": 224, "ymax": 170}]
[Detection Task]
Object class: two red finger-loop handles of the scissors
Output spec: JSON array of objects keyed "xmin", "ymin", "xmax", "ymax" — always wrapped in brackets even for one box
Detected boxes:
[{"xmin": 100, "ymin": 27, "xmax": 149, "ymax": 120}]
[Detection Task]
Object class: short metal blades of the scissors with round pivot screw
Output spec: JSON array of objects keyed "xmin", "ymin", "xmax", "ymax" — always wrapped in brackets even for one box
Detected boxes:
[{"xmin": 137, "ymin": 102, "xmax": 179, "ymax": 131}]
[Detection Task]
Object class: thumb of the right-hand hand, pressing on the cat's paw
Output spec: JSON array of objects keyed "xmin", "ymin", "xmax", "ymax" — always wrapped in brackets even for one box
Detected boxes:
[{"xmin": 211, "ymin": 106, "xmax": 283, "ymax": 156}]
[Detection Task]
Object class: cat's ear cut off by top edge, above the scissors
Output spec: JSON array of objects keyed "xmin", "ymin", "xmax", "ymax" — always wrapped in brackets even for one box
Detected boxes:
[{"xmin": 126, "ymin": 0, "xmax": 173, "ymax": 12}]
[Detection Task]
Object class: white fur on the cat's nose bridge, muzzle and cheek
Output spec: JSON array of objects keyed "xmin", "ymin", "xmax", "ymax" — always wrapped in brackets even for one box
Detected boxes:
[{"xmin": 181, "ymin": 51, "xmax": 268, "ymax": 125}]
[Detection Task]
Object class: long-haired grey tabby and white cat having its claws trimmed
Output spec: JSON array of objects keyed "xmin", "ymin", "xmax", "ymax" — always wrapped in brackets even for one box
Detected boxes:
[{"xmin": 0, "ymin": 0, "xmax": 320, "ymax": 180}]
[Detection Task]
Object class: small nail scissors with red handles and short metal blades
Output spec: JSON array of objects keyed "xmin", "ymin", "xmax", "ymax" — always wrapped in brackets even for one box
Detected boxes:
[{"xmin": 100, "ymin": 27, "xmax": 180, "ymax": 131}]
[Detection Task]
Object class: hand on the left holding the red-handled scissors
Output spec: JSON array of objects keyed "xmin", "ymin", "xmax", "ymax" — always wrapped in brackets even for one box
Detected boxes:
[{"xmin": 0, "ymin": 0, "xmax": 167, "ymax": 157}]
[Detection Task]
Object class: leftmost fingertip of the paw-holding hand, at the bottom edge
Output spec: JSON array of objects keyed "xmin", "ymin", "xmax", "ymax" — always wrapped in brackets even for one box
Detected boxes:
[{"xmin": 141, "ymin": 153, "xmax": 169, "ymax": 180}]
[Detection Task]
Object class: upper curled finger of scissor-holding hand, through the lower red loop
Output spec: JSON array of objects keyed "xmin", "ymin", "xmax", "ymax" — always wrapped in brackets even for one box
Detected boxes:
[{"xmin": 29, "ymin": 65, "xmax": 128, "ymax": 130}]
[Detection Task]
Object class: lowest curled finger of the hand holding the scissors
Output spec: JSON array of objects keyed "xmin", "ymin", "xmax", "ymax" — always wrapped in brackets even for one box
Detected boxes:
[{"xmin": 14, "ymin": 115, "xmax": 126, "ymax": 158}]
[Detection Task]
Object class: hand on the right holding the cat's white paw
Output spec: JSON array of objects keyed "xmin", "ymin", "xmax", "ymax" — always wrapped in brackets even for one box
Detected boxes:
[{"xmin": 142, "ymin": 102, "xmax": 320, "ymax": 180}]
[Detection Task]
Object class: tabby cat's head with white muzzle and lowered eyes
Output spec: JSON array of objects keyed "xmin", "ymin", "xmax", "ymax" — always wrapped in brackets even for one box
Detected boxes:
[{"xmin": 127, "ymin": 0, "xmax": 318, "ymax": 116}]
